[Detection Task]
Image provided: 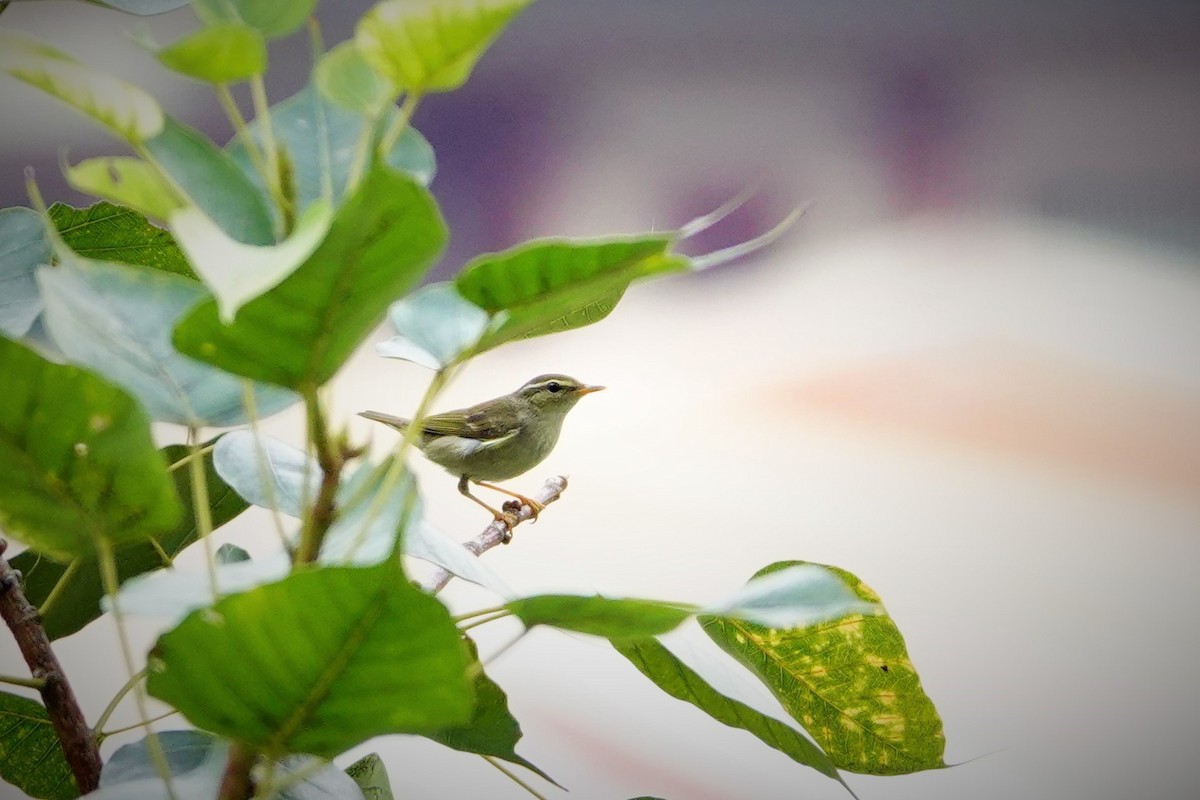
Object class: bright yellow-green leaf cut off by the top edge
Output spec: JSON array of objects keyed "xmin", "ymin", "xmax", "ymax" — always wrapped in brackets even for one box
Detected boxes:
[{"xmin": 354, "ymin": 0, "xmax": 533, "ymax": 95}]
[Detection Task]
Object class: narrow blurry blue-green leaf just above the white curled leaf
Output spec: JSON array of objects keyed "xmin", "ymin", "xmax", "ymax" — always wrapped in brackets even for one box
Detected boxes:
[{"xmin": 143, "ymin": 118, "xmax": 275, "ymax": 245}]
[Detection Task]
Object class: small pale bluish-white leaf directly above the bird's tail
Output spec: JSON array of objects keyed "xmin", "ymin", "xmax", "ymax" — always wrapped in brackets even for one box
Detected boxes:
[{"xmin": 376, "ymin": 283, "xmax": 487, "ymax": 369}]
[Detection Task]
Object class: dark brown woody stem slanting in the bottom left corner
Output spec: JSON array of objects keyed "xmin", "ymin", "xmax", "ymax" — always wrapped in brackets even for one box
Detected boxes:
[{"xmin": 0, "ymin": 539, "xmax": 102, "ymax": 794}]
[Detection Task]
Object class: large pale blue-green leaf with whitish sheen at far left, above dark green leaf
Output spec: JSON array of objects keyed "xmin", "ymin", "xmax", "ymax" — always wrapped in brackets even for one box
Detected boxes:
[{"xmin": 37, "ymin": 257, "xmax": 299, "ymax": 427}]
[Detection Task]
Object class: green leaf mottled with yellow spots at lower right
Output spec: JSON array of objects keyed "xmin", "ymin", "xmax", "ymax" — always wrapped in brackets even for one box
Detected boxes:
[{"xmin": 701, "ymin": 561, "xmax": 946, "ymax": 775}]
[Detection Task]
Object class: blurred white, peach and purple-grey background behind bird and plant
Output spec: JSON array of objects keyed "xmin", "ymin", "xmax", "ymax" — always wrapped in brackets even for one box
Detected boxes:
[{"xmin": 0, "ymin": 0, "xmax": 1200, "ymax": 800}]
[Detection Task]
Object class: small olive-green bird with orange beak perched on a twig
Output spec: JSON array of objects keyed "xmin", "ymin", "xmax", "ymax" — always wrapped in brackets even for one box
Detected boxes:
[{"xmin": 359, "ymin": 374, "xmax": 604, "ymax": 528}]
